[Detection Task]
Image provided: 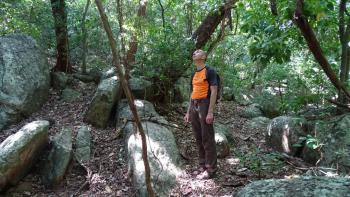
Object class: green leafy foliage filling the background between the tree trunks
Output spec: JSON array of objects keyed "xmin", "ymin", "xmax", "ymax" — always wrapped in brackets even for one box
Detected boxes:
[{"xmin": 0, "ymin": 0, "xmax": 350, "ymax": 111}]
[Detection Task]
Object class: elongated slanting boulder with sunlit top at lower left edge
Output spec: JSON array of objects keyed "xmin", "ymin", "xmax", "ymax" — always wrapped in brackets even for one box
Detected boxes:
[{"xmin": 0, "ymin": 121, "xmax": 49, "ymax": 191}]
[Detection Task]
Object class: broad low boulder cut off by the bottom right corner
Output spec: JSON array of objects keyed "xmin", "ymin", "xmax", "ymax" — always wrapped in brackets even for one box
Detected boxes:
[{"xmin": 237, "ymin": 177, "xmax": 350, "ymax": 197}]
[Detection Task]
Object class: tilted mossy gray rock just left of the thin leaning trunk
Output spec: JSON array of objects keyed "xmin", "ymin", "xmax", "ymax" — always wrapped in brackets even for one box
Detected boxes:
[{"xmin": 85, "ymin": 77, "xmax": 119, "ymax": 128}]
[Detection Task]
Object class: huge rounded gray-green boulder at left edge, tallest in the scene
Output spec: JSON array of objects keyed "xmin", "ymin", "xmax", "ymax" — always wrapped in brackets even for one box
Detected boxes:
[{"xmin": 0, "ymin": 35, "xmax": 50, "ymax": 130}]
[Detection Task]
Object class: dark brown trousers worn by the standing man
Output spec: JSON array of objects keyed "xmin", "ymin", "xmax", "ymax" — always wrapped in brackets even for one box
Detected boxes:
[{"xmin": 190, "ymin": 99, "xmax": 217, "ymax": 172}]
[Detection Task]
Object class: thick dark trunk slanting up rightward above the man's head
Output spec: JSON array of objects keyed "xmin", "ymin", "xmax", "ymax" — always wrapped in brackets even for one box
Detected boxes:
[{"xmin": 191, "ymin": 0, "xmax": 237, "ymax": 49}]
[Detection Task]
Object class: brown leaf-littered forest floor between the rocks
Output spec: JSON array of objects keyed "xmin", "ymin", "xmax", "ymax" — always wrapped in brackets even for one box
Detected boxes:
[{"xmin": 0, "ymin": 83, "xmax": 306, "ymax": 196}]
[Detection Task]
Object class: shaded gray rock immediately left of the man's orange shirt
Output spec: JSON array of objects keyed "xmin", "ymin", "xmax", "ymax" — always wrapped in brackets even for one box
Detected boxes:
[{"xmin": 174, "ymin": 77, "xmax": 191, "ymax": 103}]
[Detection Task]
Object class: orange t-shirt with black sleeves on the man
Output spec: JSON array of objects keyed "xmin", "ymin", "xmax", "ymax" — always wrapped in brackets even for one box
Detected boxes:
[{"xmin": 191, "ymin": 67, "xmax": 218, "ymax": 99}]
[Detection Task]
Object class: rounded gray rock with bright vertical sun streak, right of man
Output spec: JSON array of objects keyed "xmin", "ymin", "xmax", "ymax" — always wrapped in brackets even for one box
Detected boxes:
[{"xmin": 265, "ymin": 116, "xmax": 307, "ymax": 156}]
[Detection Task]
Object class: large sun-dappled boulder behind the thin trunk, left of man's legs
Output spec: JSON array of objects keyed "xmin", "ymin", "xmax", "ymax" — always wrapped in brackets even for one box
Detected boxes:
[{"xmin": 118, "ymin": 100, "xmax": 182, "ymax": 196}]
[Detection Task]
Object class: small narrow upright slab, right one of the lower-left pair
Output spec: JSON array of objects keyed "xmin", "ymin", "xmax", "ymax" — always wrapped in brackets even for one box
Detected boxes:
[{"xmin": 75, "ymin": 126, "xmax": 91, "ymax": 164}]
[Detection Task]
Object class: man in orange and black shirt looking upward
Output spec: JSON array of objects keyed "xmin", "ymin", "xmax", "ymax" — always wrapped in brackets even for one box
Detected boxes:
[{"xmin": 184, "ymin": 49, "xmax": 218, "ymax": 179}]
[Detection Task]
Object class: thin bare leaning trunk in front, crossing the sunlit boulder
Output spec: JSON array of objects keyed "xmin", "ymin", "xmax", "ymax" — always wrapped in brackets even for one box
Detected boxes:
[{"xmin": 95, "ymin": 0, "xmax": 155, "ymax": 197}]
